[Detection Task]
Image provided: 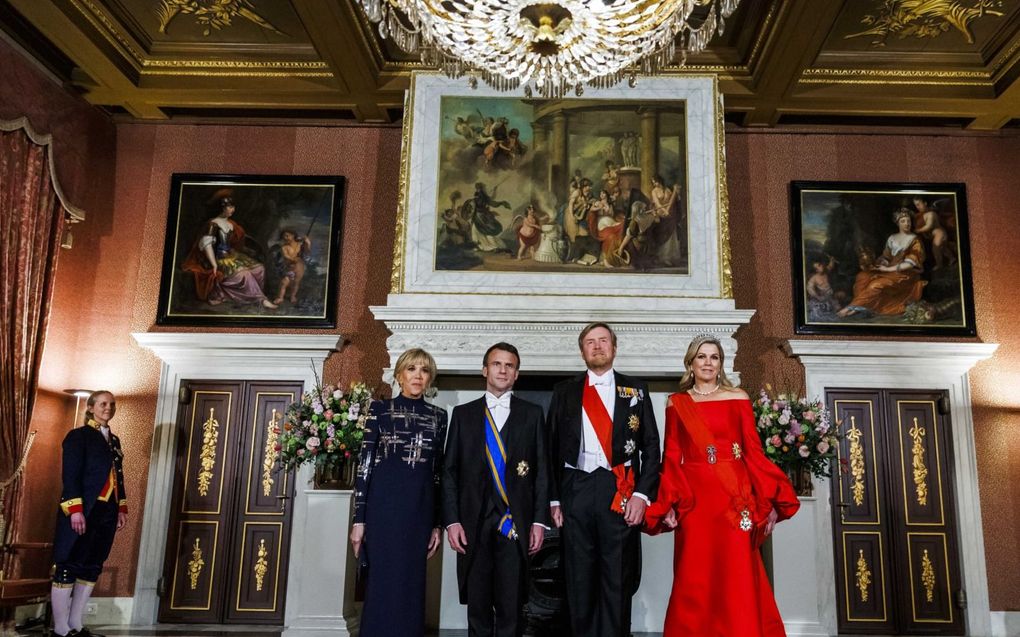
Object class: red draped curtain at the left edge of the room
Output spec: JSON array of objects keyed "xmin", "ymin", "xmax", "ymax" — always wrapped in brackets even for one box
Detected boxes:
[{"xmin": 0, "ymin": 122, "xmax": 64, "ymax": 567}]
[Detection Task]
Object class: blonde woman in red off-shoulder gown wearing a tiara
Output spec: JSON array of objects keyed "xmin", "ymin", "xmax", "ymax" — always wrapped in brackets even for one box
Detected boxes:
[{"xmin": 646, "ymin": 335, "xmax": 800, "ymax": 637}]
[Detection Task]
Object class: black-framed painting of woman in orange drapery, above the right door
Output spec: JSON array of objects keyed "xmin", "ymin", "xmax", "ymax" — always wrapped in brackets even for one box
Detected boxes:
[{"xmin": 791, "ymin": 181, "xmax": 976, "ymax": 336}]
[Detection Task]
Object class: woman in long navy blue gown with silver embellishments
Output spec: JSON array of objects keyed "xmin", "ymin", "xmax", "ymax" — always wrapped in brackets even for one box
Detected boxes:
[{"xmin": 351, "ymin": 349, "xmax": 447, "ymax": 637}]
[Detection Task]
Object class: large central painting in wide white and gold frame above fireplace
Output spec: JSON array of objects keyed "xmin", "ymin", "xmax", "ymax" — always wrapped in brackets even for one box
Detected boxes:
[{"xmin": 394, "ymin": 73, "xmax": 728, "ymax": 298}]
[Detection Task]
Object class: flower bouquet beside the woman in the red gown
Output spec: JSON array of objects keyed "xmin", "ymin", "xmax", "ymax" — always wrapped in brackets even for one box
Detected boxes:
[{"xmin": 754, "ymin": 385, "xmax": 839, "ymax": 478}]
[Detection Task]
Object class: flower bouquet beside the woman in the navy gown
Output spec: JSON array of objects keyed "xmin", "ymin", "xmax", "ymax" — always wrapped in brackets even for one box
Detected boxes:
[{"xmin": 276, "ymin": 382, "xmax": 372, "ymax": 471}]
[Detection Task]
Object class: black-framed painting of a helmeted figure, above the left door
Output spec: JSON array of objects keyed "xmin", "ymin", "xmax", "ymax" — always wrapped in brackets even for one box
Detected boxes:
[{"xmin": 156, "ymin": 173, "xmax": 344, "ymax": 328}]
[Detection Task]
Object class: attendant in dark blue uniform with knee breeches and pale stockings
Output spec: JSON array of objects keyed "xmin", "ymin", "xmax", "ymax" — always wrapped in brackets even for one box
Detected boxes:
[{"xmin": 50, "ymin": 390, "xmax": 128, "ymax": 637}]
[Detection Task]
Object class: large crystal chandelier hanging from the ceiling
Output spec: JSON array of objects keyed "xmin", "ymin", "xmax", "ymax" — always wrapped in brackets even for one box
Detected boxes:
[{"xmin": 358, "ymin": 0, "xmax": 741, "ymax": 97}]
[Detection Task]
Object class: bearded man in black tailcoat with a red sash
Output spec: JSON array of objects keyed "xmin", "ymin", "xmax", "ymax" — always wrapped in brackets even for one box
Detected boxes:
[{"xmin": 548, "ymin": 323, "xmax": 659, "ymax": 637}]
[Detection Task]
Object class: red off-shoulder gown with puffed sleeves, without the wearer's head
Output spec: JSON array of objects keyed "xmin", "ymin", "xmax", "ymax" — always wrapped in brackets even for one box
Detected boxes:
[{"xmin": 646, "ymin": 393, "xmax": 801, "ymax": 637}]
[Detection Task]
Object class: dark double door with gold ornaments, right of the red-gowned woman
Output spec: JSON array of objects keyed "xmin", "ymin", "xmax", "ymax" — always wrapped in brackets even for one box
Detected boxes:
[{"xmin": 826, "ymin": 389, "xmax": 966, "ymax": 635}]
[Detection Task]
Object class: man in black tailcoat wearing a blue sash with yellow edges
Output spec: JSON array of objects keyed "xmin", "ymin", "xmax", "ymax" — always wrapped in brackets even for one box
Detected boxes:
[{"xmin": 443, "ymin": 342, "xmax": 549, "ymax": 637}]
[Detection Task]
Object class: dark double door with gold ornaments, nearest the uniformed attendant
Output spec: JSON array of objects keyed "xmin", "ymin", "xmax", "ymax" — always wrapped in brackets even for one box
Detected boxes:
[{"xmin": 159, "ymin": 380, "xmax": 302, "ymax": 624}]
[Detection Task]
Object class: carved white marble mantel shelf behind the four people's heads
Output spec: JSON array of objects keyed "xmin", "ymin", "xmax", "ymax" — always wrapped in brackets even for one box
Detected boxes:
[{"xmin": 371, "ymin": 294, "xmax": 754, "ymax": 377}]
